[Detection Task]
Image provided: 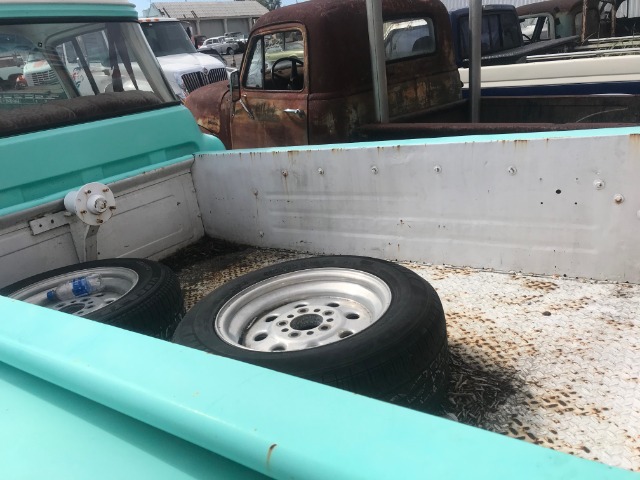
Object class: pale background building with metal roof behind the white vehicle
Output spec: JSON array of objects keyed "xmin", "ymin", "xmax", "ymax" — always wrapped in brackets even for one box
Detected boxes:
[{"xmin": 144, "ymin": 0, "xmax": 269, "ymax": 37}]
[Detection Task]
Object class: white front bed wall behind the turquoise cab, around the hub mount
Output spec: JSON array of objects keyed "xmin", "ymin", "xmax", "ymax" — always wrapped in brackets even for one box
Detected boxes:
[{"xmin": 0, "ymin": 161, "xmax": 204, "ymax": 287}]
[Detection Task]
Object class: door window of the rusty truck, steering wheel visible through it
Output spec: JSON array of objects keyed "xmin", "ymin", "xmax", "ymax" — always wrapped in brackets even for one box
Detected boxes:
[{"xmin": 243, "ymin": 30, "xmax": 305, "ymax": 91}]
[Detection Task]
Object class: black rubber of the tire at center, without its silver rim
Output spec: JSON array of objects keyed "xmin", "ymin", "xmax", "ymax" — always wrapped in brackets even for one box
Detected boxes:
[{"xmin": 173, "ymin": 256, "xmax": 448, "ymax": 412}]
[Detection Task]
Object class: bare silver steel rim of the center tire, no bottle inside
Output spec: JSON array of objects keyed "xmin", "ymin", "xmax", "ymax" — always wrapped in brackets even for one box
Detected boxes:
[{"xmin": 214, "ymin": 268, "xmax": 391, "ymax": 352}]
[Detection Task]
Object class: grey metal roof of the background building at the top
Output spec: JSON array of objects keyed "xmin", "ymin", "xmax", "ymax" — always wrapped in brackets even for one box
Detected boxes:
[{"xmin": 151, "ymin": 0, "xmax": 269, "ymax": 18}]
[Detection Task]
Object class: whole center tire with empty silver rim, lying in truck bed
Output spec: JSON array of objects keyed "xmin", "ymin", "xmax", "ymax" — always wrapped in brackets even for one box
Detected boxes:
[{"xmin": 173, "ymin": 256, "xmax": 448, "ymax": 412}]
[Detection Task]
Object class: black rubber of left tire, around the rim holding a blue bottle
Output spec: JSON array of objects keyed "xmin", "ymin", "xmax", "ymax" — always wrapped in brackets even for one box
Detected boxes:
[{"xmin": 0, "ymin": 258, "xmax": 185, "ymax": 340}]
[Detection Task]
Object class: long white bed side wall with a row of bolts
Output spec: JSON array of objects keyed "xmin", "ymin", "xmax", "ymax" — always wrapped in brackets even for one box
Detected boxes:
[{"xmin": 193, "ymin": 135, "xmax": 640, "ymax": 282}]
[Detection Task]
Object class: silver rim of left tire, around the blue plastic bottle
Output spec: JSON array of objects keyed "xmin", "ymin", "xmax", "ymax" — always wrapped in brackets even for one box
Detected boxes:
[{"xmin": 9, "ymin": 267, "xmax": 138, "ymax": 317}]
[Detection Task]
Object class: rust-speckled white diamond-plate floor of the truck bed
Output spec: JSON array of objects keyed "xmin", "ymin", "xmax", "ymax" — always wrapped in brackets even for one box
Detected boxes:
[{"xmin": 165, "ymin": 240, "xmax": 640, "ymax": 471}]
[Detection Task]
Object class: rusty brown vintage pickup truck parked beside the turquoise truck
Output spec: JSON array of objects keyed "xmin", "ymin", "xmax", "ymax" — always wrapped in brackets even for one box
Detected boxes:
[{"xmin": 186, "ymin": 0, "xmax": 640, "ymax": 149}]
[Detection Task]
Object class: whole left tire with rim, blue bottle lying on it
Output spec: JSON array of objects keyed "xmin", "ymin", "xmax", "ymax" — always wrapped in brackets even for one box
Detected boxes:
[{"xmin": 0, "ymin": 258, "xmax": 184, "ymax": 340}]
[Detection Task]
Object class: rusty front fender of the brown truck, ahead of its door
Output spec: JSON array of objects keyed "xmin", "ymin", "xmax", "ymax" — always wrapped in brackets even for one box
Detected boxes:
[{"xmin": 184, "ymin": 80, "xmax": 231, "ymax": 149}]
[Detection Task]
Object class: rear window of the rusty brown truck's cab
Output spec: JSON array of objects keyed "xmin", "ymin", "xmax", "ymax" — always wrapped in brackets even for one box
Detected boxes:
[{"xmin": 383, "ymin": 18, "xmax": 436, "ymax": 61}]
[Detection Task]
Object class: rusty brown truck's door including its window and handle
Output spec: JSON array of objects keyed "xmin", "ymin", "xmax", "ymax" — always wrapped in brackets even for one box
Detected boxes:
[{"xmin": 231, "ymin": 27, "xmax": 309, "ymax": 148}]
